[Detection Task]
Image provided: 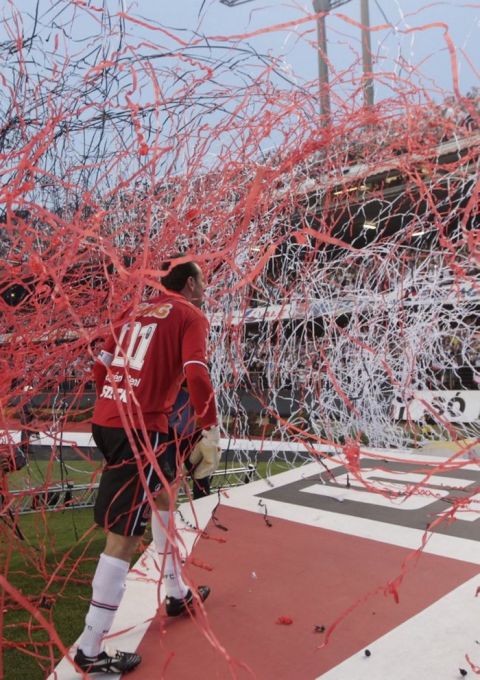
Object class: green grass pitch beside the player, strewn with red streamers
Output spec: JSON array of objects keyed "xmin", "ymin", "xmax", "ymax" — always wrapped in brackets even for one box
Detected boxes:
[{"xmin": 0, "ymin": 461, "xmax": 300, "ymax": 680}]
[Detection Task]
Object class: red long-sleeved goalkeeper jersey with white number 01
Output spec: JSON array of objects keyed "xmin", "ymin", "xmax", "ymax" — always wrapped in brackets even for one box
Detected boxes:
[{"xmin": 92, "ymin": 292, "xmax": 216, "ymax": 432}]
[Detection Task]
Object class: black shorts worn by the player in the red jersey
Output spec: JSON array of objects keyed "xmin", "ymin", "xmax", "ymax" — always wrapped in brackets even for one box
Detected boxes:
[{"xmin": 92, "ymin": 424, "xmax": 177, "ymax": 536}]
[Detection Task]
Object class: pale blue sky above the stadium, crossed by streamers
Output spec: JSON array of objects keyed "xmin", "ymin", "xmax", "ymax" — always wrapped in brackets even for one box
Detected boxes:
[{"xmin": 0, "ymin": 0, "xmax": 480, "ymax": 172}]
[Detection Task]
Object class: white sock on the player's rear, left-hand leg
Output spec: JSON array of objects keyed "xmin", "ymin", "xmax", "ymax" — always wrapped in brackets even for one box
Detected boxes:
[{"xmin": 78, "ymin": 553, "xmax": 130, "ymax": 656}]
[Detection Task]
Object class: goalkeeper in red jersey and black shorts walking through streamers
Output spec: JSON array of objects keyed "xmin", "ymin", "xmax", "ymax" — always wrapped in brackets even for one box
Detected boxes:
[{"xmin": 75, "ymin": 257, "xmax": 220, "ymax": 673}]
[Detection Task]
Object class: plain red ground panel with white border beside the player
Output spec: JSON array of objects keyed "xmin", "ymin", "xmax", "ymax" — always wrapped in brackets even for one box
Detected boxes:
[{"xmin": 128, "ymin": 506, "xmax": 479, "ymax": 680}]
